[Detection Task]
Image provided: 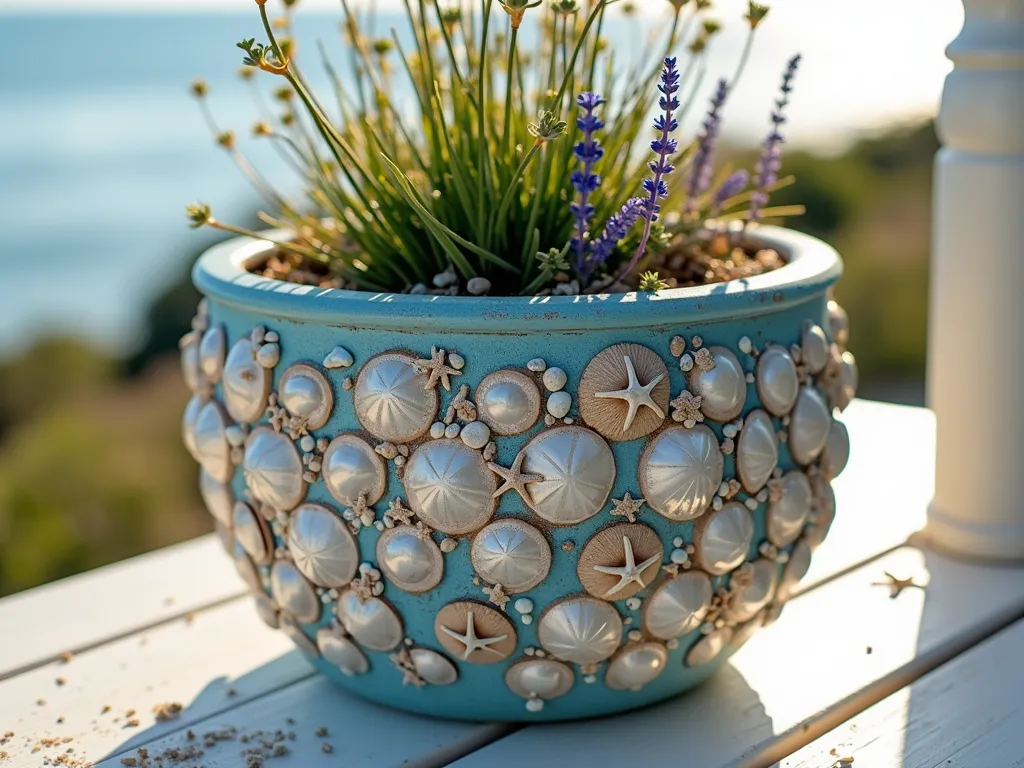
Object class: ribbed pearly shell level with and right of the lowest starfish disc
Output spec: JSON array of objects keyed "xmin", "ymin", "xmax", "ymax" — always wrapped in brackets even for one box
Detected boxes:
[{"xmin": 537, "ymin": 597, "xmax": 623, "ymax": 664}]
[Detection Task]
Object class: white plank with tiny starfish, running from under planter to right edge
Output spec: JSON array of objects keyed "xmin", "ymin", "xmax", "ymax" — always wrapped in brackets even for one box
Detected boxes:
[{"xmin": 457, "ymin": 548, "xmax": 1024, "ymax": 768}]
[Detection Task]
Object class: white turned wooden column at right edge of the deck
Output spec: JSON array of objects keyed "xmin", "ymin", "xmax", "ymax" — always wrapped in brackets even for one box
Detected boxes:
[{"xmin": 925, "ymin": 0, "xmax": 1024, "ymax": 559}]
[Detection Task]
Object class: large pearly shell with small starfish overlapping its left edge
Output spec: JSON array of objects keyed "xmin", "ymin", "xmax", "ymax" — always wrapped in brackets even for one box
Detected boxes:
[{"xmin": 522, "ymin": 426, "xmax": 615, "ymax": 525}]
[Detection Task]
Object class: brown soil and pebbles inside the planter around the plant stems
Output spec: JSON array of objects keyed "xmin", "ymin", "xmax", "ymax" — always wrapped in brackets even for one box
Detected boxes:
[{"xmin": 250, "ymin": 236, "xmax": 785, "ymax": 296}]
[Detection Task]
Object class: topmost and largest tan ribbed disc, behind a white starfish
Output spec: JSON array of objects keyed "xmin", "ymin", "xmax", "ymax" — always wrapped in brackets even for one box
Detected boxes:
[{"xmin": 578, "ymin": 344, "xmax": 672, "ymax": 440}]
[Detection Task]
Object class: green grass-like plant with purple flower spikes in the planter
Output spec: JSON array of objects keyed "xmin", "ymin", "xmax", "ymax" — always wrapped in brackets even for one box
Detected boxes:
[{"xmin": 187, "ymin": 0, "xmax": 799, "ymax": 295}]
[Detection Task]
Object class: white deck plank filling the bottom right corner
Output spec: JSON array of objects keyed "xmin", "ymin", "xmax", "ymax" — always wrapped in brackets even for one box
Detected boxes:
[{"xmin": 781, "ymin": 622, "xmax": 1024, "ymax": 768}]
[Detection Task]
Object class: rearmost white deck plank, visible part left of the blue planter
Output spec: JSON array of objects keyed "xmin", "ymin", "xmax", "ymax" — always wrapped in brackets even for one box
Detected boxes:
[{"xmin": 0, "ymin": 534, "xmax": 245, "ymax": 680}]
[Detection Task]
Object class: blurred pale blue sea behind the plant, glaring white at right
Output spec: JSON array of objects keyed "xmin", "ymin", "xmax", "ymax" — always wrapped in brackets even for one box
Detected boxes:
[{"xmin": 0, "ymin": 9, "xmax": 958, "ymax": 356}]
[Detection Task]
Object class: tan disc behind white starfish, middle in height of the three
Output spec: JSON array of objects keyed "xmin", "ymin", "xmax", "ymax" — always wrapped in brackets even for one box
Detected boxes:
[{"xmin": 577, "ymin": 522, "xmax": 665, "ymax": 600}]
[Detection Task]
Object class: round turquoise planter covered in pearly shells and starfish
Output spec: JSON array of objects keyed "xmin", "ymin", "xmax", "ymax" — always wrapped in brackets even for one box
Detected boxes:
[{"xmin": 182, "ymin": 227, "xmax": 856, "ymax": 721}]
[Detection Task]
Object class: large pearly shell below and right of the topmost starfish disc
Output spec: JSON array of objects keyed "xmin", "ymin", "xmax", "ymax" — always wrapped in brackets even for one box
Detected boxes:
[{"xmin": 637, "ymin": 424, "xmax": 725, "ymax": 522}]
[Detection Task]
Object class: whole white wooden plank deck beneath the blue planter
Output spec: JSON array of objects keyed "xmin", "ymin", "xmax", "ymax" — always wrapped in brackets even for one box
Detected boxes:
[{"xmin": 0, "ymin": 401, "xmax": 1024, "ymax": 768}]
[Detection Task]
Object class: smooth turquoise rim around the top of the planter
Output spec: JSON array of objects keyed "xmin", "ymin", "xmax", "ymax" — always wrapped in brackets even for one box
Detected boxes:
[{"xmin": 193, "ymin": 226, "xmax": 843, "ymax": 334}]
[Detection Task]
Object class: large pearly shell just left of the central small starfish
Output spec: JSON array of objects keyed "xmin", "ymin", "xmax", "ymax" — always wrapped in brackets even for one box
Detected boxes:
[{"xmin": 403, "ymin": 439, "xmax": 497, "ymax": 535}]
